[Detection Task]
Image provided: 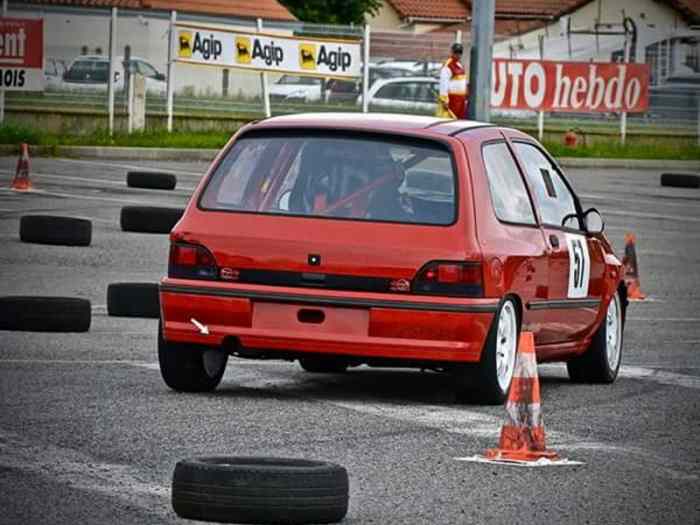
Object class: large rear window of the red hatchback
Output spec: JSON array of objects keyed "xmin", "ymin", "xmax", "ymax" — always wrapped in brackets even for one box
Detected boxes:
[{"xmin": 199, "ymin": 131, "xmax": 456, "ymax": 225}]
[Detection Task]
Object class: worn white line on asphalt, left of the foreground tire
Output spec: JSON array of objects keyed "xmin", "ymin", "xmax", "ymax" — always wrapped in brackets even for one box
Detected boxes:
[{"xmin": 0, "ymin": 429, "xmax": 174, "ymax": 520}]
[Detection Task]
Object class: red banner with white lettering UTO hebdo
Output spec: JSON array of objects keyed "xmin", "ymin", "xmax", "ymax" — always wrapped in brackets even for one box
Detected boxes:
[{"xmin": 491, "ymin": 59, "xmax": 649, "ymax": 113}]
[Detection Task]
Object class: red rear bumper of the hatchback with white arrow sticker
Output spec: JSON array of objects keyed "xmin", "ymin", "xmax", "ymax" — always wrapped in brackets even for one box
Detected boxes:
[{"xmin": 160, "ymin": 279, "xmax": 498, "ymax": 362}]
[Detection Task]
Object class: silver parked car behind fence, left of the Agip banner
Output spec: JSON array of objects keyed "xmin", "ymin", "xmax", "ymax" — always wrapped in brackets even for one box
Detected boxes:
[{"xmin": 62, "ymin": 55, "xmax": 166, "ymax": 95}]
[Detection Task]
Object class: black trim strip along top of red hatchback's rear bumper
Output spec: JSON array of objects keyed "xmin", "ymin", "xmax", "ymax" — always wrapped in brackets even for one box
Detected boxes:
[{"xmin": 160, "ymin": 284, "xmax": 498, "ymax": 313}]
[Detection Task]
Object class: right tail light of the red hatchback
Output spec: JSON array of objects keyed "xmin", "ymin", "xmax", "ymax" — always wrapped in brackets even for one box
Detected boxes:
[{"xmin": 413, "ymin": 261, "xmax": 484, "ymax": 297}]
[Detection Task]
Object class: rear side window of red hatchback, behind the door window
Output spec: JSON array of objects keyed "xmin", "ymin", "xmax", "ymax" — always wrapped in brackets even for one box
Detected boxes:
[{"xmin": 482, "ymin": 142, "xmax": 535, "ymax": 224}]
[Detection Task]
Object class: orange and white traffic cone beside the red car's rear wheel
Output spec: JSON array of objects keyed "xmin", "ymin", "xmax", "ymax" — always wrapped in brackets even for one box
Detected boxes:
[{"xmin": 486, "ymin": 332, "xmax": 559, "ymax": 461}]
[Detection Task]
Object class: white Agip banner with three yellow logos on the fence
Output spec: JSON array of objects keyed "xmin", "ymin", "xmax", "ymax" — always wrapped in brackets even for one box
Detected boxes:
[{"xmin": 176, "ymin": 24, "xmax": 362, "ymax": 78}]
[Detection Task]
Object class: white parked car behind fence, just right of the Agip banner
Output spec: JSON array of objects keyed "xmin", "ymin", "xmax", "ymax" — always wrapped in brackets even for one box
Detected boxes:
[{"xmin": 358, "ymin": 77, "xmax": 440, "ymax": 114}]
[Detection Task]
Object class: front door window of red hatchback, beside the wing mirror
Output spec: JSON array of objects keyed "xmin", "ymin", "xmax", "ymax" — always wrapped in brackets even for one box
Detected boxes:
[{"xmin": 513, "ymin": 142, "xmax": 578, "ymax": 227}]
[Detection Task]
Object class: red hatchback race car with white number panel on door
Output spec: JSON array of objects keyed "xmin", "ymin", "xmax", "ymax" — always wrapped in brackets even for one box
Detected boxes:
[{"xmin": 158, "ymin": 114, "xmax": 627, "ymax": 403}]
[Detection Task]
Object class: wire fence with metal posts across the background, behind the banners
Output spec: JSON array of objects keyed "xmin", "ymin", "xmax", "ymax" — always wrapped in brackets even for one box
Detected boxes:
[{"xmin": 6, "ymin": 3, "xmax": 700, "ymax": 145}]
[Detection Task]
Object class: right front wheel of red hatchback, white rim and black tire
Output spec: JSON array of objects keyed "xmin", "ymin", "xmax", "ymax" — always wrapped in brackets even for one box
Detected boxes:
[{"xmin": 566, "ymin": 292, "xmax": 625, "ymax": 383}]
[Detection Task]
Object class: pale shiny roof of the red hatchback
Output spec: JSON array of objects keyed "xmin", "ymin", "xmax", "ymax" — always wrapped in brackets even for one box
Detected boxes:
[{"xmin": 254, "ymin": 113, "xmax": 493, "ymax": 135}]
